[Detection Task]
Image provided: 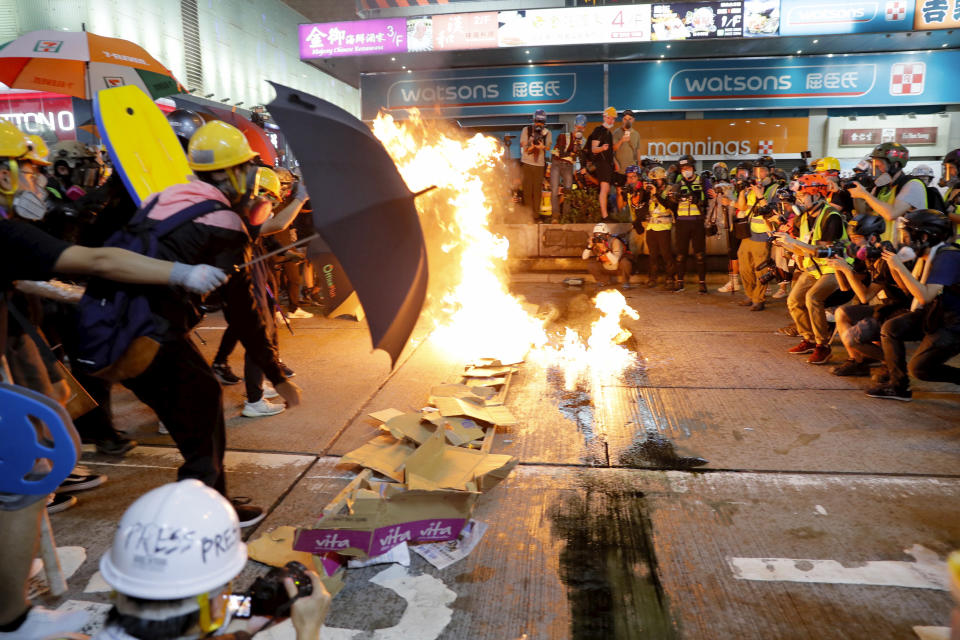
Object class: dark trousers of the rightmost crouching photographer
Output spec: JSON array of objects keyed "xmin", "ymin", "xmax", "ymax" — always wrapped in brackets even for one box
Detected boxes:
[{"xmin": 880, "ymin": 309, "xmax": 960, "ymax": 389}]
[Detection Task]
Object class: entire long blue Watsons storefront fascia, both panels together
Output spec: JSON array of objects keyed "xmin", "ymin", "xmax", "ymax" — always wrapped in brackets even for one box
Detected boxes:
[{"xmin": 360, "ymin": 50, "xmax": 960, "ymax": 120}]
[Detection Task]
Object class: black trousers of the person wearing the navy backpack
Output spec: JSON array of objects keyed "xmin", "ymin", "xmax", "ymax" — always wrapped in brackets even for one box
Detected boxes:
[{"xmin": 123, "ymin": 337, "xmax": 227, "ymax": 495}]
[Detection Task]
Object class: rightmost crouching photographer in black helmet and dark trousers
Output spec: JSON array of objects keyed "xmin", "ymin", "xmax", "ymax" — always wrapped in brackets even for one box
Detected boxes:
[{"xmin": 867, "ymin": 209, "xmax": 960, "ymax": 402}]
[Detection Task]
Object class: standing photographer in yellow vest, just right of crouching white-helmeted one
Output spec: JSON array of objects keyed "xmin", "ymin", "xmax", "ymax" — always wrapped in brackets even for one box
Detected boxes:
[{"xmin": 634, "ymin": 167, "xmax": 677, "ymax": 291}]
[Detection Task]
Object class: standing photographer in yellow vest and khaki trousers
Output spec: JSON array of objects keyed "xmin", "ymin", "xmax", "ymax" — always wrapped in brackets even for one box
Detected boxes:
[{"xmin": 734, "ymin": 156, "xmax": 777, "ymax": 311}]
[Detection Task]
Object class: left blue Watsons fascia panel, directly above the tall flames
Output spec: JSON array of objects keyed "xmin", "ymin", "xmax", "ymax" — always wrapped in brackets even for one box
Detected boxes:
[{"xmin": 360, "ymin": 65, "xmax": 604, "ymax": 120}]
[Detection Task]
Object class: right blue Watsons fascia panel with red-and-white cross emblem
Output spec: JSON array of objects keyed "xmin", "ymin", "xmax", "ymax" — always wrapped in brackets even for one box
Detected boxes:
[{"xmin": 608, "ymin": 51, "xmax": 960, "ymax": 110}]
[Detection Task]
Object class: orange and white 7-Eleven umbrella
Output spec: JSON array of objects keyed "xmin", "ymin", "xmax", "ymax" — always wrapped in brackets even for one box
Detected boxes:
[{"xmin": 0, "ymin": 31, "xmax": 183, "ymax": 100}]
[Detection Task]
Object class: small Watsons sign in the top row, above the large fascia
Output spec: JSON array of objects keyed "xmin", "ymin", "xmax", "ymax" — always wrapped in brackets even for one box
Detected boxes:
[{"xmin": 780, "ymin": 0, "xmax": 916, "ymax": 36}]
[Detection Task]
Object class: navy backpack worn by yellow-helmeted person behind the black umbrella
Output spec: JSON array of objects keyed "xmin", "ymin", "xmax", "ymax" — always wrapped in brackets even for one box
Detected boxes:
[{"xmin": 76, "ymin": 198, "xmax": 224, "ymax": 382}]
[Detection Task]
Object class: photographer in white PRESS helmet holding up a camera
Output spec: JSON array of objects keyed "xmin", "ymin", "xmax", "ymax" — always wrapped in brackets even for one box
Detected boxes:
[{"xmin": 91, "ymin": 480, "xmax": 330, "ymax": 640}]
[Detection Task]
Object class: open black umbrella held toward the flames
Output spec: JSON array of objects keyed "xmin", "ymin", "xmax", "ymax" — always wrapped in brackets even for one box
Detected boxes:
[{"xmin": 268, "ymin": 83, "xmax": 427, "ymax": 364}]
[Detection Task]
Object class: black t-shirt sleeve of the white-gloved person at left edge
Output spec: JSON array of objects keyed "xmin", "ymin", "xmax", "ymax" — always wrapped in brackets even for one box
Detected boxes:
[{"xmin": 0, "ymin": 220, "xmax": 70, "ymax": 290}]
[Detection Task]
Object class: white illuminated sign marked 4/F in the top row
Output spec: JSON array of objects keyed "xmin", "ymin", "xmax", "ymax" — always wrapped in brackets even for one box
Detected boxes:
[{"xmin": 499, "ymin": 4, "xmax": 650, "ymax": 47}]
